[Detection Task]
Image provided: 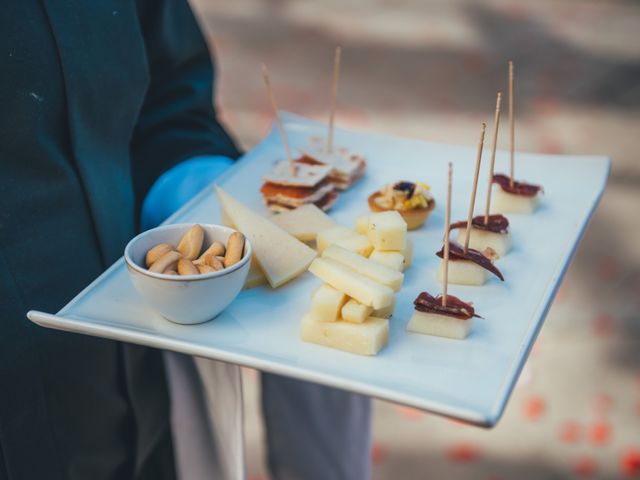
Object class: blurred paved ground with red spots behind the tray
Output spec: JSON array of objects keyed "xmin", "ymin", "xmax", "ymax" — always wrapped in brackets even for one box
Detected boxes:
[{"xmin": 192, "ymin": 0, "xmax": 640, "ymax": 480}]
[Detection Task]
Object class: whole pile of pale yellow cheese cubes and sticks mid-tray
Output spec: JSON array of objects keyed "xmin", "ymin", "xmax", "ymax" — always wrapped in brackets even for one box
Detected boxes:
[{"xmin": 302, "ymin": 211, "xmax": 410, "ymax": 355}]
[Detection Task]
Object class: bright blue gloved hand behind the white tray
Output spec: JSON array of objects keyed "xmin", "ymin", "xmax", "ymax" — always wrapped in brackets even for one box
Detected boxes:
[{"xmin": 140, "ymin": 156, "xmax": 233, "ymax": 231}]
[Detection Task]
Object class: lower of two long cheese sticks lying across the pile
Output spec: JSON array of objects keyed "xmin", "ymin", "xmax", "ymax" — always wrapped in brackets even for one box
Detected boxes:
[{"xmin": 309, "ymin": 258, "xmax": 393, "ymax": 308}]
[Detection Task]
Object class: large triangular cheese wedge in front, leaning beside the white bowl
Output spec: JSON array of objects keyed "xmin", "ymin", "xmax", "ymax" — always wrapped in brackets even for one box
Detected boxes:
[{"xmin": 215, "ymin": 186, "xmax": 316, "ymax": 288}]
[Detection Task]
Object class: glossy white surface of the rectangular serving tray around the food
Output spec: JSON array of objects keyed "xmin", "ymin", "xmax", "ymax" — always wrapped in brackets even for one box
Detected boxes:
[{"xmin": 29, "ymin": 114, "xmax": 610, "ymax": 426}]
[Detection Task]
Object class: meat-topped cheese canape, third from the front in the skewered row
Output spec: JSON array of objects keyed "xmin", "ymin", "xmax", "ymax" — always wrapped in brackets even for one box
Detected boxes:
[{"xmin": 451, "ymin": 214, "xmax": 511, "ymax": 258}]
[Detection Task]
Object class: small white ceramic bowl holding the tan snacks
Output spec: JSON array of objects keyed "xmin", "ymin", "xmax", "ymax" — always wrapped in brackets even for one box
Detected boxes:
[{"xmin": 124, "ymin": 223, "xmax": 251, "ymax": 325}]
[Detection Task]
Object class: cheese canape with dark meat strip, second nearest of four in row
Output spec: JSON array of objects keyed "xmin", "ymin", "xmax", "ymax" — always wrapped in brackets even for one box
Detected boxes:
[{"xmin": 436, "ymin": 242, "xmax": 504, "ymax": 285}]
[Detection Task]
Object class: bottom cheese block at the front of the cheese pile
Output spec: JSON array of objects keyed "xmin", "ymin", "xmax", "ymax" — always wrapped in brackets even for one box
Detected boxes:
[{"xmin": 301, "ymin": 315, "xmax": 389, "ymax": 355}]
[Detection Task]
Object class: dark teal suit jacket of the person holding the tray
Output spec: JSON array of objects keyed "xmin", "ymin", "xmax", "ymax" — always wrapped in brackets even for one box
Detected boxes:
[{"xmin": 0, "ymin": 0, "xmax": 237, "ymax": 480}]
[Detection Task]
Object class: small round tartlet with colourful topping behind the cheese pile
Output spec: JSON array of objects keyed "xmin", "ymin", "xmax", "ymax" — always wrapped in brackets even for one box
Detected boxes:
[{"xmin": 368, "ymin": 181, "xmax": 436, "ymax": 230}]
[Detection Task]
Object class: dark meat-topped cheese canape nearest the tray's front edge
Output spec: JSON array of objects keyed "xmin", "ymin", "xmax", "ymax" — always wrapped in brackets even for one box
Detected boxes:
[{"xmin": 407, "ymin": 292, "xmax": 479, "ymax": 340}]
